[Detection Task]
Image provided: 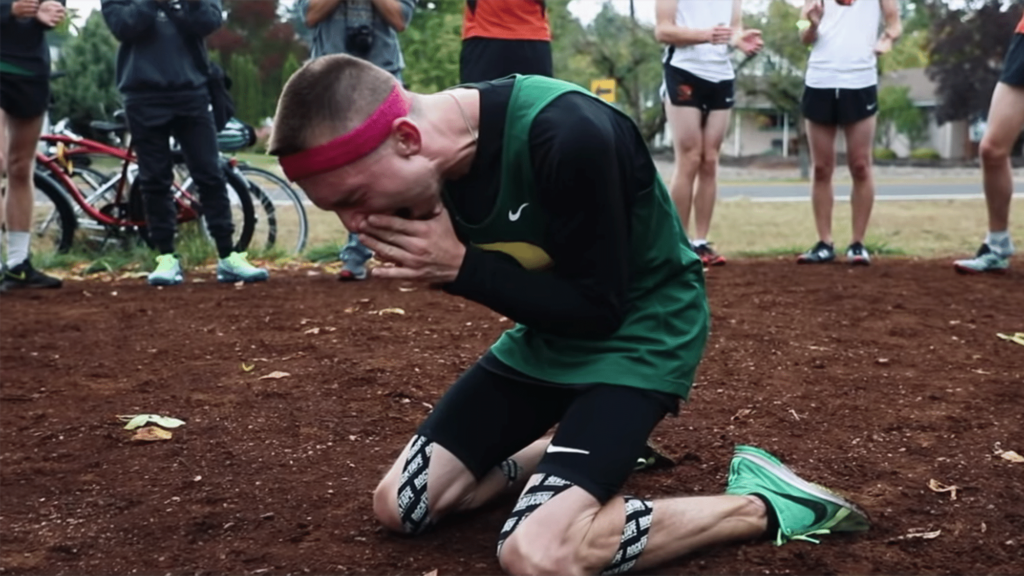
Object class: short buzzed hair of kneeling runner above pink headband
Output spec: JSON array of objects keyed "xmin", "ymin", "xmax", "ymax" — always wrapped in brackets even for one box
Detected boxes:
[{"xmin": 267, "ymin": 54, "xmax": 397, "ymax": 156}]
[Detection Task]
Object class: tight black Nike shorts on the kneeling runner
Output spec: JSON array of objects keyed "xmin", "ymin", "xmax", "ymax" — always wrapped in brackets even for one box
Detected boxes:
[{"xmin": 418, "ymin": 353, "xmax": 679, "ymax": 503}]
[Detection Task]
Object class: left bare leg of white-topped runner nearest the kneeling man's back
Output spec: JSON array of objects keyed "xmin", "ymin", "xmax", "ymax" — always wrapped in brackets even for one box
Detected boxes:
[{"xmin": 665, "ymin": 100, "xmax": 710, "ymax": 238}]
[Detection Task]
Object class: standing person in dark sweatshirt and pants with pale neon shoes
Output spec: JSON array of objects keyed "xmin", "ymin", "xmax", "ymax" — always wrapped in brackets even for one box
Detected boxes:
[{"xmin": 102, "ymin": 0, "xmax": 268, "ymax": 286}]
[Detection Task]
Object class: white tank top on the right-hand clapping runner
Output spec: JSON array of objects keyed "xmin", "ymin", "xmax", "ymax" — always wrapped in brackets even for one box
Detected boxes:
[{"xmin": 805, "ymin": 0, "xmax": 882, "ymax": 89}]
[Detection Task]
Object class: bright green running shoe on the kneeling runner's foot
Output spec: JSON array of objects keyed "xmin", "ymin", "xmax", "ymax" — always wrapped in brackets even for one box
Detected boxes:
[{"xmin": 725, "ymin": 446, "xmax": 870, "ymax": 546}]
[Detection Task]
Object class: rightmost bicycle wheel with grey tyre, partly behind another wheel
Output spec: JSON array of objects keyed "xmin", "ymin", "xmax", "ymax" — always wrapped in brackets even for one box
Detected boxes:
[{"xmin": 236, "ymin": 164, "xmax": 309, "ymax": 254}]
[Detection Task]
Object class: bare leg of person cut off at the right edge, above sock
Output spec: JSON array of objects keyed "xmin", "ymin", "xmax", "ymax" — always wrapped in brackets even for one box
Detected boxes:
[{"xmin": 981, "ymin": 82, "xmax": 1024, "ymax": 232}]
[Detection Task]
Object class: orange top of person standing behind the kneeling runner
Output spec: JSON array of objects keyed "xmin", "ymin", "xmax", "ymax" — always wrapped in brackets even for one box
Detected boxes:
[{"xmin": 462, "ymin": 0, "xmax": 551, "ymax": 41}]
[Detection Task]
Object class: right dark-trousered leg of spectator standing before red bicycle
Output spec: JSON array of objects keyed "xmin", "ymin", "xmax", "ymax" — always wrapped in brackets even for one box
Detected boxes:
[{"xmin": 172, "ymin": 114, "xmax": 234, "ymax": 258}]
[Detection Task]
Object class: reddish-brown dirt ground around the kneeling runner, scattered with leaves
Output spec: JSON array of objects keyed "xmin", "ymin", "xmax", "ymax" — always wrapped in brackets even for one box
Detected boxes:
[{"xmin": 0, "ymin": 260, "xmax": 1024, "ymax": 575}]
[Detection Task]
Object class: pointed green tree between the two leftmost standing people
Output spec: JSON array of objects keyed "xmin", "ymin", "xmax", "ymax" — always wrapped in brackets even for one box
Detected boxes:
[{"xmin": 52, "ymin": 10, "xmax": 121, "ymax": 134}]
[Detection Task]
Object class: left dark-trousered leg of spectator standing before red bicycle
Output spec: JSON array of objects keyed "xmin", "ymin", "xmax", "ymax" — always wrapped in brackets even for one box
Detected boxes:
[{"xmin": 128, "ymin": 114, "xmax": 177, "ymax": 254}]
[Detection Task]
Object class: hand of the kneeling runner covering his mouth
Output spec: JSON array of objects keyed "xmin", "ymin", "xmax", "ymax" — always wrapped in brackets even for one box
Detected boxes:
[{"xmin": 358, "ymin": 210, "xmax": 466, "ymax": 284}]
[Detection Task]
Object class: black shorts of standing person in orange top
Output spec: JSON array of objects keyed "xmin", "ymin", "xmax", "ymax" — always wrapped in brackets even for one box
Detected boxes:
[{"xmin": 459, "ymin": 37, "xmax": 554, "ymax": 84}]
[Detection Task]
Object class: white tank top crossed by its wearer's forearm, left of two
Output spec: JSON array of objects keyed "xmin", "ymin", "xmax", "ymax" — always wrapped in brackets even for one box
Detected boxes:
[{"xmin": 666, "ymin": 0, "xmax": 736, "ymax": 82}]
